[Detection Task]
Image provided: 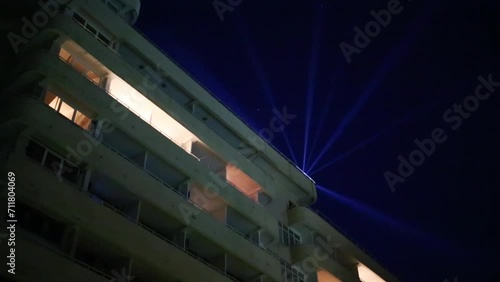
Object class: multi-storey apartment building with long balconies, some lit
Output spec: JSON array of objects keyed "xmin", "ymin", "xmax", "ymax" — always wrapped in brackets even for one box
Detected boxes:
[{"xmin": 0, "ymin": 0, "xmax": 398, "ymax": 282}]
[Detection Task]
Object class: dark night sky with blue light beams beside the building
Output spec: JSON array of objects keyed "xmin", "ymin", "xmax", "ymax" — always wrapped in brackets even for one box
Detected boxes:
[{"xmin": 136, "ymin": 0, "xmax": 500, "ymax": 282}]
